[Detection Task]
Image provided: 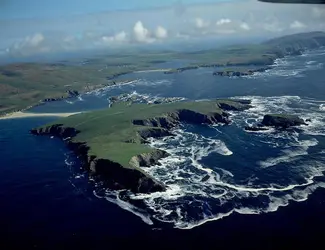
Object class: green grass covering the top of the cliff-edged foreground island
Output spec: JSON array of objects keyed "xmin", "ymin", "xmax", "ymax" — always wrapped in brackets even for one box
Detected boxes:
[{"xmin": 46, "ymin": 101, "xmax": 222, "ymax": 167}]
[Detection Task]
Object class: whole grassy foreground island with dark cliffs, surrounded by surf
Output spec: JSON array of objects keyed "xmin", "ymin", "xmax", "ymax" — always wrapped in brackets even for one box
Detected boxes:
[{"xmin": 30, "ymin": 99, "xmax": 250, "ymax": 193}]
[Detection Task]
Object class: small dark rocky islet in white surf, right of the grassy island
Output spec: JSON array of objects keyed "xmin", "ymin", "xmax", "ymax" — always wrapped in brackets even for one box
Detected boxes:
[{"xmin": 262, "ymin": 114, "xmax": 307, "ymax": 128}]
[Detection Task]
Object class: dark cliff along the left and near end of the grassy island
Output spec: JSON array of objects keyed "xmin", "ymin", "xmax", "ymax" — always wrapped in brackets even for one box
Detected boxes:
[{"xmin": 30, "ymin": 124, "xmax": 166, "ymax": 193}]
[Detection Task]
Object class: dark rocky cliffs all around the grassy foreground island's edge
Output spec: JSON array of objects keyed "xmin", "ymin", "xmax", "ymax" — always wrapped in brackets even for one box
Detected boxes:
[{"xmin": 30, "ymin": 100, "xmax": 250, "ymax": 193}]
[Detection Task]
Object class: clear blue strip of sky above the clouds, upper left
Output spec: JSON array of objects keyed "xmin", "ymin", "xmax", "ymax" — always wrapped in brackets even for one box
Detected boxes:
[{"xmin": 0, "ymin": 0, "xmax": 230, "ymax": 20}]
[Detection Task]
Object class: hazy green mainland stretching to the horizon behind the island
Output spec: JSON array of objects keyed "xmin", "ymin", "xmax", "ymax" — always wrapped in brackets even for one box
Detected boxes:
[{"xmin": 0, "ymin": 32, "xmax": 325, "ymax": 115}]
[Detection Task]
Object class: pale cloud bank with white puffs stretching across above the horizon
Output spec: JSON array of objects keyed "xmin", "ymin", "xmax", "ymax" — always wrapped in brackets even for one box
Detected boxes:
[{"xmin": 0, "ymin": 0, "xmax": 325, "ymax": 57}]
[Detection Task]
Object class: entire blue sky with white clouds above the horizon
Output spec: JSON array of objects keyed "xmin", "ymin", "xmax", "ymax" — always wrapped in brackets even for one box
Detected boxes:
[{"xmin": 0, "ymin": 0, "xmax": 325, "ymax": 58}]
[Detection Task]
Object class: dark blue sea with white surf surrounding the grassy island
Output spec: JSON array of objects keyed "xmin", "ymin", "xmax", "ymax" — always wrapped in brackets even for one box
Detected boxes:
[{"xmin": 0, "ymin": 50, "xmax": 325, "ymax": 249}]
